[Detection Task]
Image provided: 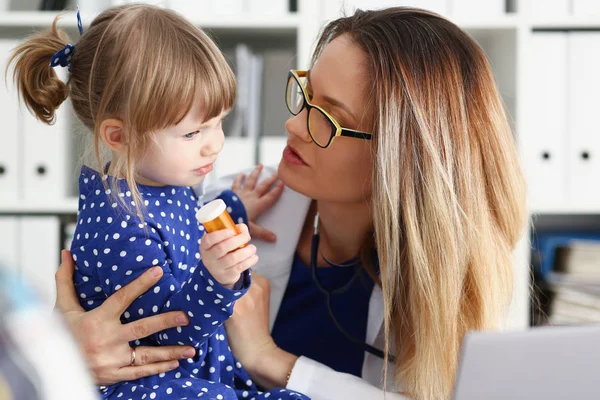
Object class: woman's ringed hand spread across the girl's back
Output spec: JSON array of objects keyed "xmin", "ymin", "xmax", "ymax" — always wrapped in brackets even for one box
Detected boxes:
[{"xmin": 55, "ymin": 250, "xmax": 195, "ymax": 385}]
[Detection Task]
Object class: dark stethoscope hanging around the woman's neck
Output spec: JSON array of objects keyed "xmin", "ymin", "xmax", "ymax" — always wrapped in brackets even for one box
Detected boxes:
[{"xmin": 310, "ymin": 212, "xmax": 395, "ymax": 363}]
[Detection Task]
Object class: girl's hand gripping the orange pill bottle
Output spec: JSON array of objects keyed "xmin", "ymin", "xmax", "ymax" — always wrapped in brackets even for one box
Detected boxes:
[{"xmin": 200, "ymin": 224, "xmax": 258, "ymax": 289}]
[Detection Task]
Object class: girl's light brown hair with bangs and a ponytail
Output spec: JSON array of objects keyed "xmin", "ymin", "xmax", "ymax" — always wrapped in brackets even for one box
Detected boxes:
[{"xmin": 9, "ymin": 4, "xmax": 236, "ymax": 217}]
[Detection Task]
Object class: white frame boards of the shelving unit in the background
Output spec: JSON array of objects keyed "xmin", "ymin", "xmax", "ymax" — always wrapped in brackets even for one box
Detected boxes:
[{"xmin": 0, "ymin": 0, "xmax": 600, "ymax": 329}]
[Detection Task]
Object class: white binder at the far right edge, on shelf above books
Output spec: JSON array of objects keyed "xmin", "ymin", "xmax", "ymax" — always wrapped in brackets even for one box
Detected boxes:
[{"xmin": 564, "ymin": 31, "xmax": 600, "ymax": 208}]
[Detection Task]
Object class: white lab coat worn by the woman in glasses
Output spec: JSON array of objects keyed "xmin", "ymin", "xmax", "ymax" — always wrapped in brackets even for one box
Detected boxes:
[{"xmin": 196, "ymin": 167, "xmax": 407, "ymax": 400}]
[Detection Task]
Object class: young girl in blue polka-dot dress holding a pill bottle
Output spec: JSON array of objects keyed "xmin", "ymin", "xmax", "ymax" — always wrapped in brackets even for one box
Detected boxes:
[{"xmin": 12, "ymin": 5, "xmax": 306, "ymax": 399}]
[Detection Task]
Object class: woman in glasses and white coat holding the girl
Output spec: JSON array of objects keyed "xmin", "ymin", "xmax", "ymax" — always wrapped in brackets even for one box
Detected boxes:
[{"xmin": 55, "ymin": 8, "xmax": 526, "ymax": 399}]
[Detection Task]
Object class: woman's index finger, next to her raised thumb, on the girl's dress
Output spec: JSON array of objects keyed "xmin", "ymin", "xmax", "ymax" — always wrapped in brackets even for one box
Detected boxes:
[{"xmin": 96, "ymin": 267, "xmax": 163, "ymax": 318}]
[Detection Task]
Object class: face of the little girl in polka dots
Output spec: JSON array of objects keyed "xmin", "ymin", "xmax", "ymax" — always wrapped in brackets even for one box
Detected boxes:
[{"xmin": 136, "ymin": 102, "xmax": 225, "ymax": 186}]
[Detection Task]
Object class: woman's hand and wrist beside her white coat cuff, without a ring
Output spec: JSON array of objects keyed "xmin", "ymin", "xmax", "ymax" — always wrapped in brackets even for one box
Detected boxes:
[{"xmin": 225, "ymin": 273, "xmax": 298, "ymax": 389}]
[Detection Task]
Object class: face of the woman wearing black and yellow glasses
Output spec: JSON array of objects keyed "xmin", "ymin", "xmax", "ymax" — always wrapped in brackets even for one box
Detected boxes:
[{"xmin": 279, "ymin": 35, "xmax": 373, "ymax": 203}]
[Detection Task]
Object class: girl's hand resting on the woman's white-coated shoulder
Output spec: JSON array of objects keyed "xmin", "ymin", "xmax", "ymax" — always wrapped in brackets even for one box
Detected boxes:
[{"xmin": 231, "ymin": 164, "xmax": 283, "ymax": 242}]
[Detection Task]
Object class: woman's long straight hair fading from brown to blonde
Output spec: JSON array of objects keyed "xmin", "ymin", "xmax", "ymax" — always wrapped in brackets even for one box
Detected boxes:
[{"xmin": 313, "ymin": 8, "xmax": 527, "ymax": 399}]
